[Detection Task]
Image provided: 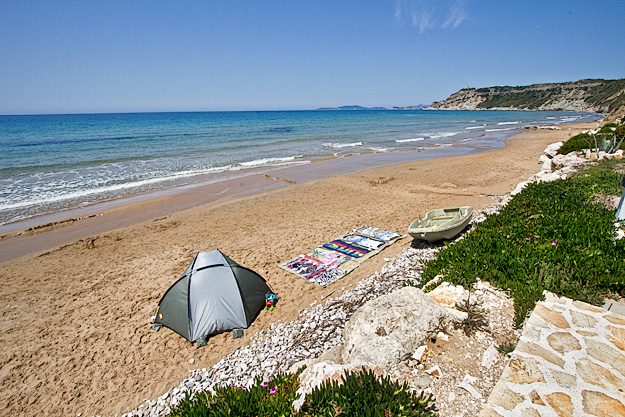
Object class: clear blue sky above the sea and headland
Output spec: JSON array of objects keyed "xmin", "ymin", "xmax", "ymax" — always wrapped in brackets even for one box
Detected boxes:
[{"xmin": 0, "ymin": 0, "xmax": 625, "ymax": 114}]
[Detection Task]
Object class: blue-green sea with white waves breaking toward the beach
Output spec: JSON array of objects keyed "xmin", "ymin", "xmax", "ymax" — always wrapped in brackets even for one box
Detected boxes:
[{"xmin": 0, "ymin": 110, "xmax": 602, "ymax": 227}]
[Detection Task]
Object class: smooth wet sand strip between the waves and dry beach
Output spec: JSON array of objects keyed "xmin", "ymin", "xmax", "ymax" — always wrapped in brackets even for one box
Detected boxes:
[{"xmin": 0, "ymin": 139, "xmax": 488, "ymax": 263}]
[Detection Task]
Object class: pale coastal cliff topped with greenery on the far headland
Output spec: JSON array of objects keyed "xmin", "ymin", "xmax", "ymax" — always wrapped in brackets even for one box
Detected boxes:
[{"xmin": 428, "ymin": 78, "xmax": 625, "ymax": 113}]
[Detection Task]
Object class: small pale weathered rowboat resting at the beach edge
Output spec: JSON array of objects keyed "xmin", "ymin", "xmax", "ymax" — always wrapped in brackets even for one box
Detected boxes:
[{"xmin": 408, "ymin": 206, "xmax": 473, "ymax": 242}]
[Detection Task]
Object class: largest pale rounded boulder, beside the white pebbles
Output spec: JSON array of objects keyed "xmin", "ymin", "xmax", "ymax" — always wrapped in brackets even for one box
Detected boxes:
[{"xmin": 342, "ymin": 287, "xmax": 455, "ymax": 369}]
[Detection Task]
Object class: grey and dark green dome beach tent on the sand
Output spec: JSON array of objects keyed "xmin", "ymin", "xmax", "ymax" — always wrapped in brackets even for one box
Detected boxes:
[{"xmin": 152, "ymin": 250, "xmax": 272, "ymax": 347}]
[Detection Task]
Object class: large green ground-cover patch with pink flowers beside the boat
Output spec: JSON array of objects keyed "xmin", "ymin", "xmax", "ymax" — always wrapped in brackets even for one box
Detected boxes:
[{"xmin": 423, "ymin": 160, "xmax": 625, "ymax": 326}]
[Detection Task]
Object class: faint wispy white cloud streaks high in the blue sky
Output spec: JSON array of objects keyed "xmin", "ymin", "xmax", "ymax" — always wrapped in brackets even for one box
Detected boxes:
[{"xmin": 395, "ymin": 0, "xmax": 466, "ymax": 33}]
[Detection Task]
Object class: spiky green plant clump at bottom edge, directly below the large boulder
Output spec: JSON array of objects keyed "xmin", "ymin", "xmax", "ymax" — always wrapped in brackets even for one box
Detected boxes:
[{"xmin": 301, "ymin": 370, "xmax": 436, "ymax": 417}]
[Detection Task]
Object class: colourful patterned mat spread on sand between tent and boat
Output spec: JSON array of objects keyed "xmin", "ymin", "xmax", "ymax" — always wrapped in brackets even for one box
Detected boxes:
[{"xmin": 278, "ymin": 226, "xmax": 405, "ymax": 287}]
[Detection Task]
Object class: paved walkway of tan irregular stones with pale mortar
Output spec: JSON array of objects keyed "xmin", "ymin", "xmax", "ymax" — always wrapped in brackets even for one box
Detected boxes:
[{"xmin": 480, "ymin": 293, "xmax": 625, "ymax": 417}]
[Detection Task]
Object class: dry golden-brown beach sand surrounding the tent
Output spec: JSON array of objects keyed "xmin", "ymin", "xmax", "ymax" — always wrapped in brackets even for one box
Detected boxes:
[{"xmin": 0, "ymin": 123, "xmax": 598, "ymax": 416}]
